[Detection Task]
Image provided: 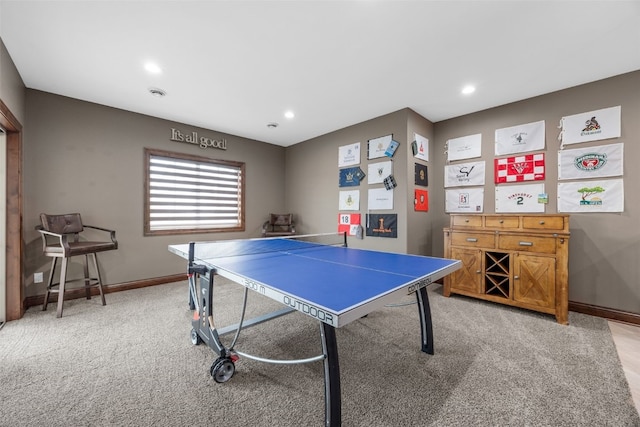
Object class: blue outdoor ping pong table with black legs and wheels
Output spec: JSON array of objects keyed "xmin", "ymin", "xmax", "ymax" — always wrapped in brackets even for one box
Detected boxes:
[{"xmin": 169, "ymin": 233, "xmax": 461, "ymax": 426}]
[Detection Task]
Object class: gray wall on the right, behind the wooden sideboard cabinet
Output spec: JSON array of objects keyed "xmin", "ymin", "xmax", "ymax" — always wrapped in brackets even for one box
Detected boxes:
[{"xmin": 429, "ymin": 71, "xmax": 640, "ymax": 313}]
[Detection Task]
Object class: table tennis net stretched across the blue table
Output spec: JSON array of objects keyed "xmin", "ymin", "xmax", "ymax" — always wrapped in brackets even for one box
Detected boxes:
[{"xmin": 189, "ymin": 233, "xmax": 347, "ymax": 261}]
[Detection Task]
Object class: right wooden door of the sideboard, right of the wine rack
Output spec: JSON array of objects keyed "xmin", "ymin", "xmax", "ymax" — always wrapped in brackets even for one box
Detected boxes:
[{"xmin": 513, "ymin": 253, "xmax": 556, "ymax": 309}]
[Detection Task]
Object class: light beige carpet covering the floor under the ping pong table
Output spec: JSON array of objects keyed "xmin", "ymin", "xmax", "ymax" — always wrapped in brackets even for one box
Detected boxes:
[{"xmin": 0, "ymin": 279, "xmax": 640, "ymax": 427}]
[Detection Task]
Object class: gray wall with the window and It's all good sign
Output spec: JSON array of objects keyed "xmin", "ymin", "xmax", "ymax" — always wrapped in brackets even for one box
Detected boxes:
[{"xmin": 23, "ymin": 89, "xmax": 285, "ymax": 296}]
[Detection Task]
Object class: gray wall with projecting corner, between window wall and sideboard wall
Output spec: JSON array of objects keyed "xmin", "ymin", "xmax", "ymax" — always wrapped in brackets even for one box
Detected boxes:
[{"xmin": 286, "ymin": 109, "xmax": 431, "ymax": 254}]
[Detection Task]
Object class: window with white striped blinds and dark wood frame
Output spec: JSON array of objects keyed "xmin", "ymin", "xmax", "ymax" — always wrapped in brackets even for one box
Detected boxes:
[{"xmin": 144, "ymin": 148, "xmax": 244, "ymax": 236}]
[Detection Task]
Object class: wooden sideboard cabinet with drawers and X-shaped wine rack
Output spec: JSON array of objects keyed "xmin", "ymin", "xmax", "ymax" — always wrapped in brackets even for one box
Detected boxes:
[{"xmin": 443, "ymin": 214, "xmax": 569, "ymax": 325}]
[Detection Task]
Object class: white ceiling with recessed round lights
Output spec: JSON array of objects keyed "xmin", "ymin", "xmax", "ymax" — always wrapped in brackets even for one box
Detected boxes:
[{"xmin": 0, "ymin": 0, "xmax": 640, "ymax": 146}]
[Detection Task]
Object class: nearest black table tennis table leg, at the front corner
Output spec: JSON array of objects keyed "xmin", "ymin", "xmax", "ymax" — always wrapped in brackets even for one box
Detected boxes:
[{"xmin": 320, "ymin": 322, "xmax": 342, "ymax": 427}]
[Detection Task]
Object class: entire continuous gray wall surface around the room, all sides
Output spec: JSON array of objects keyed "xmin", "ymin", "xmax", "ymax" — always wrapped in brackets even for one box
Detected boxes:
[{"xmin": 6, "ymin": 30, "xmax": 640, "ymax": 314}]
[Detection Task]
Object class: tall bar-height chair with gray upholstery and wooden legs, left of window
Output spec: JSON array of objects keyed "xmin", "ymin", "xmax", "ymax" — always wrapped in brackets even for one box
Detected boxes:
[{"xmin": 36, "ymin": 213, "xmax": 118, "ymax": 317}]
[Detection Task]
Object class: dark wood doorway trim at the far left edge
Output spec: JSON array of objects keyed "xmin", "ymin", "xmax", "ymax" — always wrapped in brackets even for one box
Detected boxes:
[{"xmin": 0, "ymin": 99, "xmax": 26, "ymax": 321}]
